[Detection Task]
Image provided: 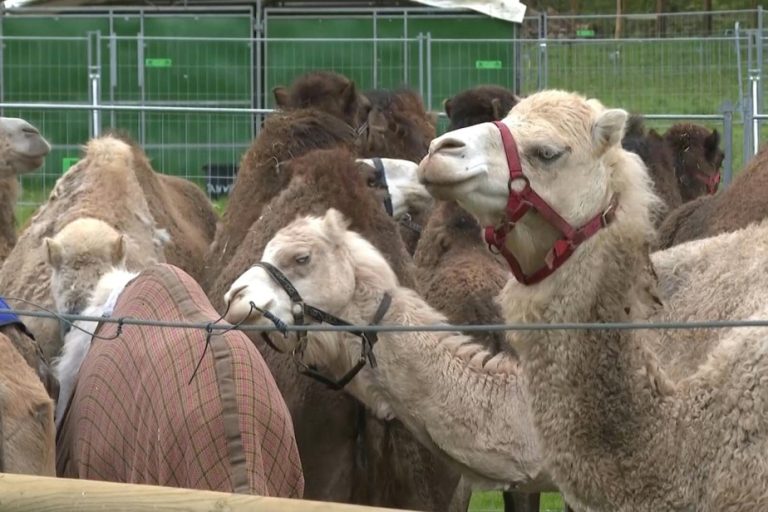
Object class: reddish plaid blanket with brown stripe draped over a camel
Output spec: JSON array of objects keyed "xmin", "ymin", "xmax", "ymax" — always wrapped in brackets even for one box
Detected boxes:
[{"xmin": 56, "ymin": 265, "xmax": 304, "ymax": 497}]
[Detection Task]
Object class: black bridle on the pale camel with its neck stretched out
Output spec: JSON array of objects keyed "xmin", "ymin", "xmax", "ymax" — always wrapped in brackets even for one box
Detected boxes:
[{"xmin": 251, "ymin": 261, "xmax": 392, "ymax": 390}]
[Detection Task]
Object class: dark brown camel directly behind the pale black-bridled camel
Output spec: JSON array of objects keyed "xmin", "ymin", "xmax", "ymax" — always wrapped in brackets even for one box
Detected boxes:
[{"xmin": 208, "ymin": 149, "xmax": 468, "ymax": 511}]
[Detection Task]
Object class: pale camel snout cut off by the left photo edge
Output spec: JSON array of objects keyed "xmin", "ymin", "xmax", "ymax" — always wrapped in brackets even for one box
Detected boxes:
[{"xmin": 0, "ymin": 117, "xmax": 51, "ymax": 178}]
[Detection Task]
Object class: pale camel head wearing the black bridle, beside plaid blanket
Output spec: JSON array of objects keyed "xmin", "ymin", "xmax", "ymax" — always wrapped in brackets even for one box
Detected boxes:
[{"xmin": 224, "ymin": 209, "xmax": 397, "ymax": 416}]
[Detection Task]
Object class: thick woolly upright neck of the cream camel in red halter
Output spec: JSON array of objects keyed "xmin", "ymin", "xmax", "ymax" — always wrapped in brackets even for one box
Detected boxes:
[{"xmin": 502, "ymin": 222, "xmax": 672, "ymax": 501}]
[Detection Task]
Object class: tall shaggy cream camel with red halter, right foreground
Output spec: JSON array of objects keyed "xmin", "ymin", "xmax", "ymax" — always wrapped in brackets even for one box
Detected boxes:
[{"xmin": 419, "ymin": 91, "xmax": 768, "ymax": 511}]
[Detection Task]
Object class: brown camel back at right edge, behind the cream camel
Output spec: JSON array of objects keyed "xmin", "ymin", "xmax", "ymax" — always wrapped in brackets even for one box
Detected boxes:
[{"xmin": 657, "ymin": 144, "xmax": 768, "ymax": 249}]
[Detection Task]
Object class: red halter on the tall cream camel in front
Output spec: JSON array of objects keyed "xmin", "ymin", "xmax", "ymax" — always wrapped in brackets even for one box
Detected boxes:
[{"xmin": 485, "ymin": 121, "xmax": 618, "ymax": 285}]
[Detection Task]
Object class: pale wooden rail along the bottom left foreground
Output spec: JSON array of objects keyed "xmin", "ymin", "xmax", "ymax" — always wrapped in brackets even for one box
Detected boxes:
[{"xmin": 0, "ymin": 473, "xmax": 414, "ymax": 512}]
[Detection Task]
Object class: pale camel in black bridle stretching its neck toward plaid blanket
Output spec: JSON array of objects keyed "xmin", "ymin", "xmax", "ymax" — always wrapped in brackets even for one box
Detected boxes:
[{"xmin": 225, "ymin": 209, "xmax": 546, "ymax": 490}]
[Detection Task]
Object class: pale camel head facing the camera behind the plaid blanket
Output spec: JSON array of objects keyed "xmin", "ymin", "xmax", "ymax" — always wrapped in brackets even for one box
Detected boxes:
[{"xmin": 44, "ymin": 217, "xmax": 126, "ymax": 314}]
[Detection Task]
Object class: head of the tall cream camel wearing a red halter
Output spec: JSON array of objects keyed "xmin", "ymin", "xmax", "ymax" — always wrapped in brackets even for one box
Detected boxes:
[{"xmin": 418, "ymin": 90, "xmax": 647, "ymax": 280}]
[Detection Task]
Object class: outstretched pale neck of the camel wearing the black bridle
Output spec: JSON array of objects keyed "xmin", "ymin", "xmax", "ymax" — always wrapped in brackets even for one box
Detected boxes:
[{"xmin": 336, "ymin": 288, "xmax": 543, "ymax": 489}]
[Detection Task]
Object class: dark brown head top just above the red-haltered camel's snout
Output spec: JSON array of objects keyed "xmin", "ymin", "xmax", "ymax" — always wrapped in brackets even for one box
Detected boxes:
[{"xmin": 443, "ymin": 85, "xmax": 518, "ymax": 130}]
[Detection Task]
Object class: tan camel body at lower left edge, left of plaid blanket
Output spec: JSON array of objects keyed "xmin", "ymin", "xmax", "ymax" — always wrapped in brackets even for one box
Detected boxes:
[{"xmin": 0, "ymin": 334, "xmax": 56, "ymax": 476}]
